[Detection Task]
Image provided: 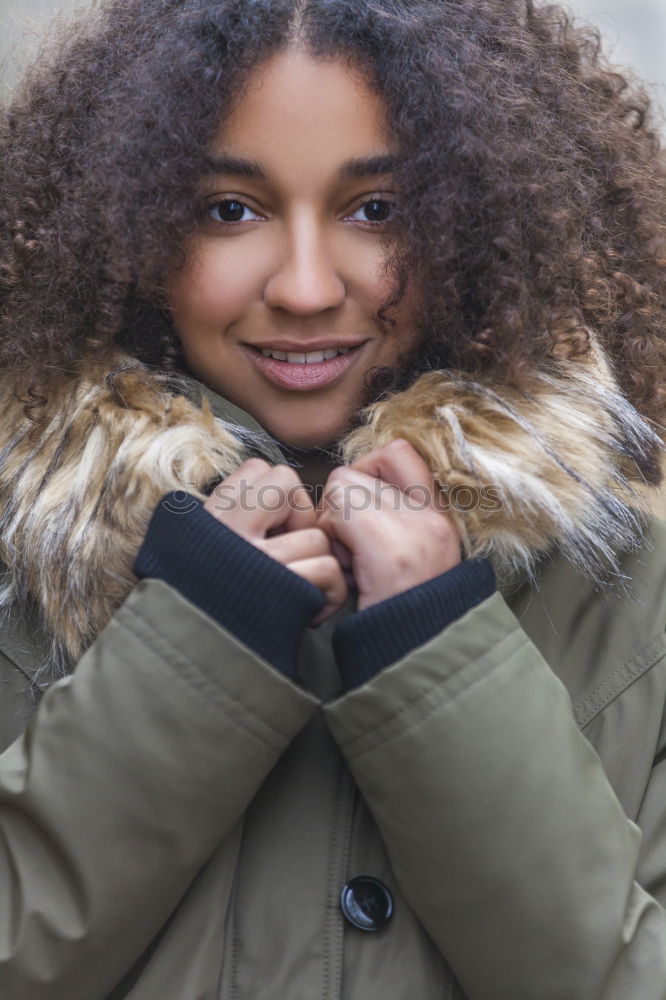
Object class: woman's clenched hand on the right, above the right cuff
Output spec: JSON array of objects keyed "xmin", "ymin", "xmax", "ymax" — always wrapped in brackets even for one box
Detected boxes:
[{"xmin": 318, "ymin": 438, "xmax": 461, "ymax": 611}]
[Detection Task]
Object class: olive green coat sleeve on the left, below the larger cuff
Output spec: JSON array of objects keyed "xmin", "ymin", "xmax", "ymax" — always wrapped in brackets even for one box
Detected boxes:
[{"xmin": 0, "ymin": 580, "xmax": 318, "ymax": 1000}]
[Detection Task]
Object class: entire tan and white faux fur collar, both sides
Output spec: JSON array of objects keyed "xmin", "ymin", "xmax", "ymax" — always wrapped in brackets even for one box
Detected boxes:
[{"xmin": 0, "ymin": 342, "xmax": 656, "ymax": 688}]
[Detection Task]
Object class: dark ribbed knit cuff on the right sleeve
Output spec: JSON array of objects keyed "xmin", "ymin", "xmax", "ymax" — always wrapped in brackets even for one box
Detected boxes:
[{"xmin": 332, "ymin": 559, "xmax": 496, "ymax": 690}]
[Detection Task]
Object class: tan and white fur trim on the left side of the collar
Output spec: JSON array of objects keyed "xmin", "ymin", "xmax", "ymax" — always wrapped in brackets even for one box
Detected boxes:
[{"xmin": 0, "ymin": 358, "xmax": 278, "ymax": 687}]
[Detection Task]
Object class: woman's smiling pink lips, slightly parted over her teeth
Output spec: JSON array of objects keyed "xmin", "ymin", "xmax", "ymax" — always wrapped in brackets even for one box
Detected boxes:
[{"xmin": 246, "ymin": 341, "xmax": 367, "ymax": 392}]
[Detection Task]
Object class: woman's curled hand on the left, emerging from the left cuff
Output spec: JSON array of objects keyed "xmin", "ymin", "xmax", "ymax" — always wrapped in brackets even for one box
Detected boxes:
[{"xmin": 204, "ymin": 458, "xmax": 348, "ymax": 628}]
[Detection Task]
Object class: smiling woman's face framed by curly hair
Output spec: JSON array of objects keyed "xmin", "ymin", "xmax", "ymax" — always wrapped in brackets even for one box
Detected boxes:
[{"xmin": 168, "ymin": 50, "xmax": 416, "ymax": 448}]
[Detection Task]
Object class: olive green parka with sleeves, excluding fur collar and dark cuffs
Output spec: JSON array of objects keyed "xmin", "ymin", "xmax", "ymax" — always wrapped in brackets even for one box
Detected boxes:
[{"xmin": 0, "ymin": 362, "xmax": 666, "ymax": 1000}]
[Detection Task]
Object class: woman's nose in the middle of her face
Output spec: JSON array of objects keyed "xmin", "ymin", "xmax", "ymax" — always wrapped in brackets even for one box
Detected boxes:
[{"xmin": 264, "ymin": 226, "xmax": 347, "ymax": 316}]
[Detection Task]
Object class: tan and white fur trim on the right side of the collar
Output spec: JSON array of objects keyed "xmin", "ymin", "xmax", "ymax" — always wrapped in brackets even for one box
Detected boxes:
[{"xmin": 340, "ymin": 335, "xmax": 663, "ymax": 586}]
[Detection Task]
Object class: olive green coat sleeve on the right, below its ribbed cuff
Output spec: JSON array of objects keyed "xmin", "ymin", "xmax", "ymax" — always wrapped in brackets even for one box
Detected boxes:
[{"xmin": 325, "ymin": 593, "xmax": 666, "ymax": 1000}]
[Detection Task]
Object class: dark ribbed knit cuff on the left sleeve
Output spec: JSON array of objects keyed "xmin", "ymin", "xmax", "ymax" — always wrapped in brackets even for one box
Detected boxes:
[{"xmin": 133, "ymin": 490, "xmax": 326, "ymax": 679}]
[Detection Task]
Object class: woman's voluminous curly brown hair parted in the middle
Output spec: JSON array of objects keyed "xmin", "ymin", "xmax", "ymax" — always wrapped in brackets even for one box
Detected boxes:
[{"xmin": 0, "ymin": 0, "xmax": 666, "ymax": 470}]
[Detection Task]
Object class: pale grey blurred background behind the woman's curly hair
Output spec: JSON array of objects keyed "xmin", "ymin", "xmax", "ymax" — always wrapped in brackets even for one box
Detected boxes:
[{"xmin": 0, "ymin": 0, "xmax": 666, "ymax": 114}]
